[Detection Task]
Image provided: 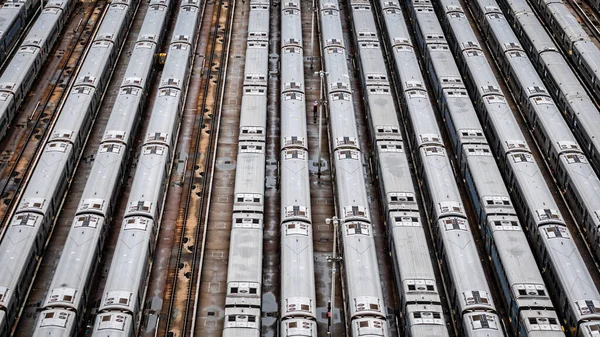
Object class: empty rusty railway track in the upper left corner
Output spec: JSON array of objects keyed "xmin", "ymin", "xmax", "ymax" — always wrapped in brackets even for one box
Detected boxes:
[{"xmin": 0, "ymin": 0, "xmax": 108, "ymax": 231}]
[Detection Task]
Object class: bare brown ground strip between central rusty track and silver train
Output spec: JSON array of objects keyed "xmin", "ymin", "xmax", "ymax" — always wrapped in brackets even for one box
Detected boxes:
[{"xmin": 191, "ymin": 1, "xmax": 249, "ymax": 337}]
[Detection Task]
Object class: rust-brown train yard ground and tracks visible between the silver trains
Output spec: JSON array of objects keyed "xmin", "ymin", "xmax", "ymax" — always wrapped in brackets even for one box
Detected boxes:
[{"xmin": 0, "ymin": 0, "xmax": 600, "ymax": 337}]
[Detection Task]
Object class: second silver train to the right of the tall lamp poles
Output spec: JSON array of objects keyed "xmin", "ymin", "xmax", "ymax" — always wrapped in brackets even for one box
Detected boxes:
[{"xmin": 349, "ymin": 0, "xmax": 449, "ymax": 337}]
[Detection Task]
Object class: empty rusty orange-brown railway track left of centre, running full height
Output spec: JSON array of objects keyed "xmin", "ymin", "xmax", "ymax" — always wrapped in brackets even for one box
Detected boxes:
[{"xmin": 166, "ymin": 0, "xmax": 235, "ymax": 337}]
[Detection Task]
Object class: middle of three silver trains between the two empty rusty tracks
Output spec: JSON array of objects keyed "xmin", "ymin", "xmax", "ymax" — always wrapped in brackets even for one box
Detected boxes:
[{"xmin": 33, "ymin": 0, "xmax": 170, "ymax": 337}]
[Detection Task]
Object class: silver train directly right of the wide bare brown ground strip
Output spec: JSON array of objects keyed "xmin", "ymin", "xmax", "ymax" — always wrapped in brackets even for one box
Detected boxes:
[{"xmin": 223, "ymin": 0, "xmax": 270, "ymax": 337}]
